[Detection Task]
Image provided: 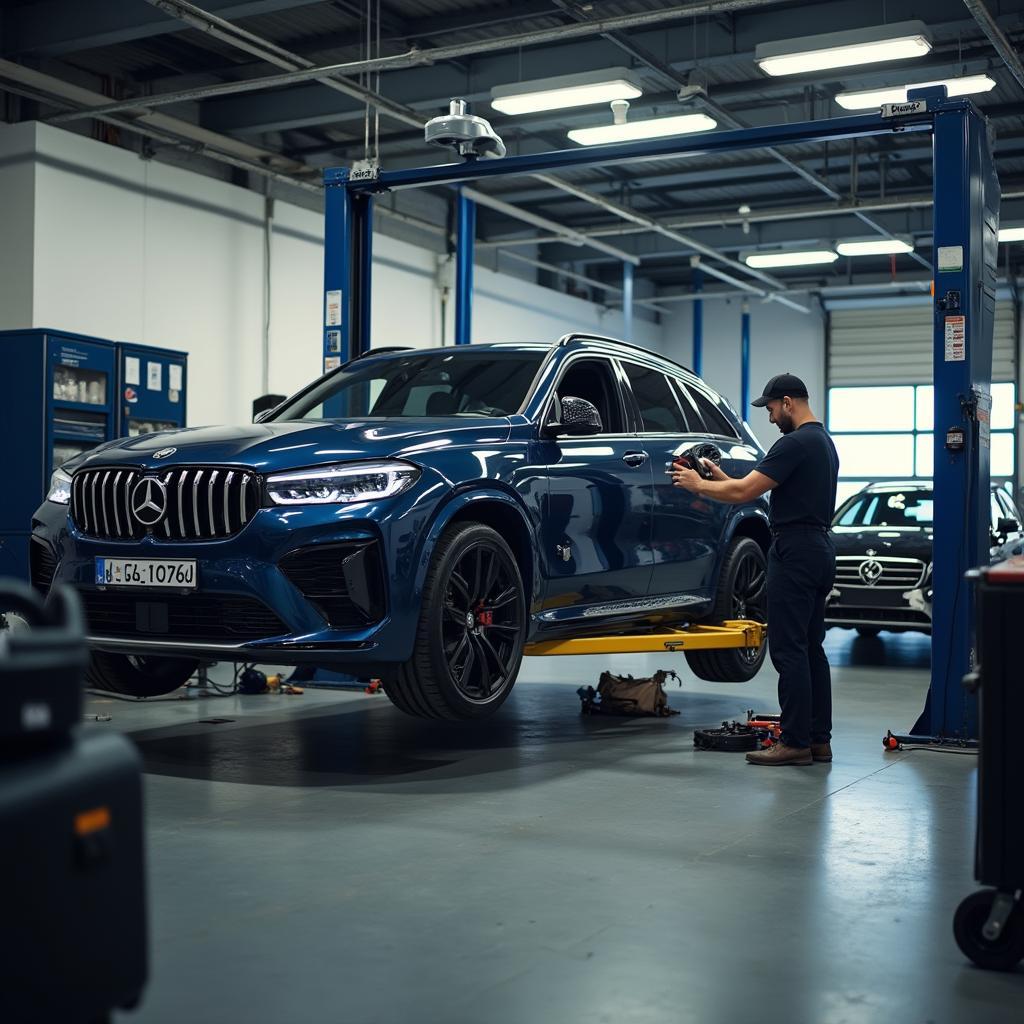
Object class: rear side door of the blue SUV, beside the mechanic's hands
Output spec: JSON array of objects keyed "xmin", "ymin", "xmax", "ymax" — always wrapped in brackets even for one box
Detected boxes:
[{"xmin": 623, "ymin": 360, "xmax": 722, "ymax": 605}]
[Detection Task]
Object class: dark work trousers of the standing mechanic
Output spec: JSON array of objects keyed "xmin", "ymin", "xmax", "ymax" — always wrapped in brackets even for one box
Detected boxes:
[{"xmin": 768, "ymin": 527, "xmax": 836, "ymax": 750}]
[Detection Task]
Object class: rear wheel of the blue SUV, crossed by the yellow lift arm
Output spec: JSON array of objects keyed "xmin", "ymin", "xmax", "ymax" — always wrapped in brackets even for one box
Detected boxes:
[{"xmin": 684, "ymin": 537, "xmax": 768, "ymax": 683}]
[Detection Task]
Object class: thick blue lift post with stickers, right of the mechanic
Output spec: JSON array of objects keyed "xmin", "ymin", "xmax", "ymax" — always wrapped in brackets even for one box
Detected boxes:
[{"xmin": 911, "ymin": 97, "xmax": 999, "ymax": 738}]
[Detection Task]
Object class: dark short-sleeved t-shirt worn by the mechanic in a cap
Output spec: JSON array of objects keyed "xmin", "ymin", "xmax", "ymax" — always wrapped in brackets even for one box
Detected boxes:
[{"xmin": 757, "ymin": 422, "xmax": 839, "ymax": 527}]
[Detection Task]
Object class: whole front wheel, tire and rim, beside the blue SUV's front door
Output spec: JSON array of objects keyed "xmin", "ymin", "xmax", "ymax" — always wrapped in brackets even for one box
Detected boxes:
[{"xmin": 384, "ymin": 523, "xmax": 526, "ymax": 721}]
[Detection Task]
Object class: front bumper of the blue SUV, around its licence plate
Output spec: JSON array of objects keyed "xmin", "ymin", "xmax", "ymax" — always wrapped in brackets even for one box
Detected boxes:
[{"xmin": 33, "ymin": 492, "xmax": 429, "ymax": 673}]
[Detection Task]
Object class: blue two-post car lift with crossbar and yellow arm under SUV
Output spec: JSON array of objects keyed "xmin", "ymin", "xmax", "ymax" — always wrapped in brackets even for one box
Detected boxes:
[{"xmin": 324, "ymin": 86, "xmax": 999, "ymax": 729}]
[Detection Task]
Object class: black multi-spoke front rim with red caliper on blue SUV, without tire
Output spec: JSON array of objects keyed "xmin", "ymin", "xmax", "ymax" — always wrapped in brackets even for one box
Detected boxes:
[{"xmin": 441, "ymin": 539, "xmax": 523, "ymax": 701}]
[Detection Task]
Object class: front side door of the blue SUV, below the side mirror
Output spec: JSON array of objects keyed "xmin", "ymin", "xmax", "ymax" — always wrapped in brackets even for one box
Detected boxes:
[{"xmin": 539, "ymin": 353, "xmax": 652, "ymax": 622}]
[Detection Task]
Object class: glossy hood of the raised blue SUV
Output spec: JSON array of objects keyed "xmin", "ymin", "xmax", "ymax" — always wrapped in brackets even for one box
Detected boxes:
[{"xmin": 66, "ymin": 418, "xmax": 511, "ymax": 472}]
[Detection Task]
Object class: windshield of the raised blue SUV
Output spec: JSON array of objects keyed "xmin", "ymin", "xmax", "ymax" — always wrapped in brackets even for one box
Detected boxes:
[{"xmin": 273, "ymin": 348, "xmax": 546, "ymax": 422}]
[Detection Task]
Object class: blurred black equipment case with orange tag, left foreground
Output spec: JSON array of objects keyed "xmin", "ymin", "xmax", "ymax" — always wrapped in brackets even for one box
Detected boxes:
[{"xmin": 0, "ymin": 580, "xmax": 148, "ymax": 1024}]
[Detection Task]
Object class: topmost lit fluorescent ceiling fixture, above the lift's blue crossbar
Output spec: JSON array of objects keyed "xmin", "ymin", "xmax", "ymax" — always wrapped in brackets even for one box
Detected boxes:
[{"xmin": 754, "ymin": 22, "xmax": 932, "ymax": 77}]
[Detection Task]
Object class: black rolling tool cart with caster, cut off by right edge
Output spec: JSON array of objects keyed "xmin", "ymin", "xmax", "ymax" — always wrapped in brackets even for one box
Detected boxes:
[{"xmin": 953, "ymin": 557, "xmax": 1024, "ymax": 971}]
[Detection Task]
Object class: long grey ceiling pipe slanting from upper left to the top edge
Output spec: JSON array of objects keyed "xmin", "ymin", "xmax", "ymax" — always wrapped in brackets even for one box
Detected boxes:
[{"xmin": 41, "ymin": 0, "xmax": 787, "ymax": 122}]
